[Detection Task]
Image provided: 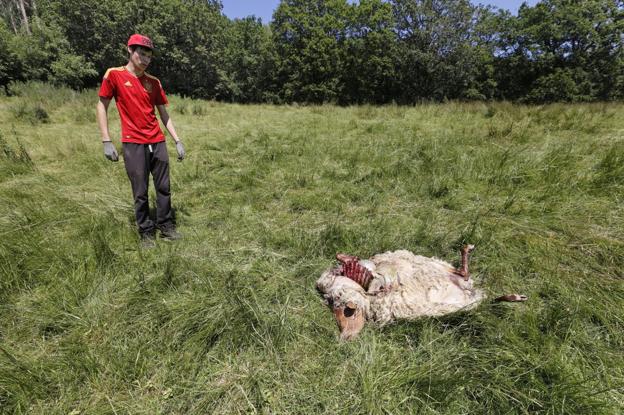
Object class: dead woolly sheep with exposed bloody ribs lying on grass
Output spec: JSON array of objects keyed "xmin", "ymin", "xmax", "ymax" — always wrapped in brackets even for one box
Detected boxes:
[{"xmin": 316, "ymin": 245, "xmax": 526, "ymax": 340}]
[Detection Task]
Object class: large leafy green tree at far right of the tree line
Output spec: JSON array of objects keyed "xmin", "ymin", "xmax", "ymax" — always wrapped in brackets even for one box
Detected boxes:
[{"xmin": 501, "ymin": 0, "xmax": 624, "ymax": 102}]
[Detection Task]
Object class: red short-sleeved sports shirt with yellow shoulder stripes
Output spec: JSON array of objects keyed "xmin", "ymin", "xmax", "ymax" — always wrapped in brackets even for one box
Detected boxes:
[{"xmin": 99, "ymin": 66, "xmax": 168, "ymax": 144}]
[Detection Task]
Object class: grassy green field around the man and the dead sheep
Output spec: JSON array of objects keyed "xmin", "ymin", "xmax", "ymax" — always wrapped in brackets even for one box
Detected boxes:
[{"xmin": 0, "ymin": 85, "xmax": 624, "ymax": 415}]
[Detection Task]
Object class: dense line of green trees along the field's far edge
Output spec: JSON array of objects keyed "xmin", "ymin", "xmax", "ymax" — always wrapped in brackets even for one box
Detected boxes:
[{"xmin": 0, "ymin": 0, "xmax": 624, "ymax": 104}]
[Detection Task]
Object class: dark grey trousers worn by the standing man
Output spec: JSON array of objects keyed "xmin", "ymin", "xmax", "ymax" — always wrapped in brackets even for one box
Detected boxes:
[{"xmin": 122, "ymin": 141, "xmax": 173, "ymax": 234}]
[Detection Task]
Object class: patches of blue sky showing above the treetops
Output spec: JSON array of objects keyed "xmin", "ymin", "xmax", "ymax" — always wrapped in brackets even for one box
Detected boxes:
[{"xmin": 222, "ymin": 0, "xmax": 538, "ymax": 23}]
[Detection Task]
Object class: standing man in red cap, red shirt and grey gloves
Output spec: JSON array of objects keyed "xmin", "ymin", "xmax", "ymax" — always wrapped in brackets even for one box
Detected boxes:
[{"xmin": 97, "ymin": 34, "xmax": 185, "ymax": 248}]
